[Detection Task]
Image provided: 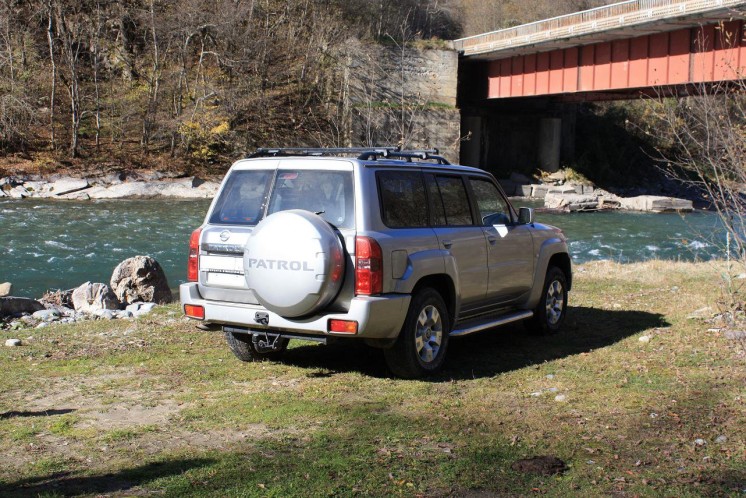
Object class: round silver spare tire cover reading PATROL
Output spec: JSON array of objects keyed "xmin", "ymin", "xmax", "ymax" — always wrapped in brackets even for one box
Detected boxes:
[{"xmin": 243, "ymin": 209, "xmax": 345, "ymax": 318}]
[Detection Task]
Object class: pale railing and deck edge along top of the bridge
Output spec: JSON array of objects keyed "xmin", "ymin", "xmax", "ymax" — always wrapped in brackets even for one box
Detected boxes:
[{"xmin": 453, "ymin": 0, "xmax": 746, "ymax": 56}]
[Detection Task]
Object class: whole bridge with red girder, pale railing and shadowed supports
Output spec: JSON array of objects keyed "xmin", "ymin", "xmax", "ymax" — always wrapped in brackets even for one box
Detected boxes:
[{"xmin": 454, "ymin": 0, "xmax": 746, "ymax": 171}]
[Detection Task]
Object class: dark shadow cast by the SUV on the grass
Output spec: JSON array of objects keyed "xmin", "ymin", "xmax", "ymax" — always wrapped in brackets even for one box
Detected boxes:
[{"xmin": 283, "ymin": 306, "xmax": 669, "ymax": 382}]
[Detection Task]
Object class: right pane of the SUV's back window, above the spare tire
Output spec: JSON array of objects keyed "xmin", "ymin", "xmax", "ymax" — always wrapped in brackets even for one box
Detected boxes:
[{"xmin": 267, "ymin": 170, "xmax": 355, "ymax": 228}]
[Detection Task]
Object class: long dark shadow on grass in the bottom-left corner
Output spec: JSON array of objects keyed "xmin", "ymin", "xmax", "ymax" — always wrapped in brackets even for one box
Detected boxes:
[{"xmin": 0, "ymin": 458, "xmax": 215, "ymax": 497}]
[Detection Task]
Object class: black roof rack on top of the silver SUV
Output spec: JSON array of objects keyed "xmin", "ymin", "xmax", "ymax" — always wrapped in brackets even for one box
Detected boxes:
[{"xmin": 249, "ymin": 147, "xmax": 451, "ymax": 165}]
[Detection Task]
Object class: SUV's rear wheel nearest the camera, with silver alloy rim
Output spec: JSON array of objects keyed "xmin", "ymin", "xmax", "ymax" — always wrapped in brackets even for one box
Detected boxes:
[{"xmin": 383, "ymin": 287, "xmax": 451, "ymax": 379}]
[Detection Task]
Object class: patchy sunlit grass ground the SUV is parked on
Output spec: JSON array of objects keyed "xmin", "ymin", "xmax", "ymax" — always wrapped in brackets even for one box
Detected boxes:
[{"xmin": 0, "ymin": 261, "xmax": 746, "ymax": 497}]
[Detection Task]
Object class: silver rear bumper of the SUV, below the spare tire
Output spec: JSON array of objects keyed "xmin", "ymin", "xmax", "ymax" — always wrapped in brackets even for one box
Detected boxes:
[{"xmin": 179, "ymin": 283, "xmax": 411, "ymax": 339}]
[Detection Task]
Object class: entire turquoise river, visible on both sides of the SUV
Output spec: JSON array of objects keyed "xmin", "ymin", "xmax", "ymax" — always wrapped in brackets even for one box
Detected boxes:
[{"xmin": 0, "ymin": 200, "xmax": 724, "ymax": 297}]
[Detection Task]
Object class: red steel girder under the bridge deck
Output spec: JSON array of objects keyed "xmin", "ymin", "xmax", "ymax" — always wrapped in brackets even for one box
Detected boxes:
[{"xmin": 487, "ymin": 20, "xmax": 746, "ymax": 99}]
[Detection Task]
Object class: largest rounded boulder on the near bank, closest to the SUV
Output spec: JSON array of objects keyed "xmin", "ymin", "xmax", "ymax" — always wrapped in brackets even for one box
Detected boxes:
[{"xmin": 110, "ymin": 256, "xmax": 173, "ymax": 304}]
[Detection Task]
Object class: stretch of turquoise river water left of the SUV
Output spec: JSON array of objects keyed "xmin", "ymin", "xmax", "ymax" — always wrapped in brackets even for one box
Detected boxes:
[{"xmin": 0, "ymin": 200, "xmax": 209, "ymax": 297}]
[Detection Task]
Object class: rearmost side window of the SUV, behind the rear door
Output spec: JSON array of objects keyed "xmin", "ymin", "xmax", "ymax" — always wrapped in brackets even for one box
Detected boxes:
[{"xmin": 377, "ymin": 171, "xmax": 427, "ymax": 228}]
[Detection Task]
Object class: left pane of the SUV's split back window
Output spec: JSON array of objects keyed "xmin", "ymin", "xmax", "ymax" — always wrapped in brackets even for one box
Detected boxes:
[{"xmin": 210, "ymin": 170, "xmax": 273, "ymax": 225}]
